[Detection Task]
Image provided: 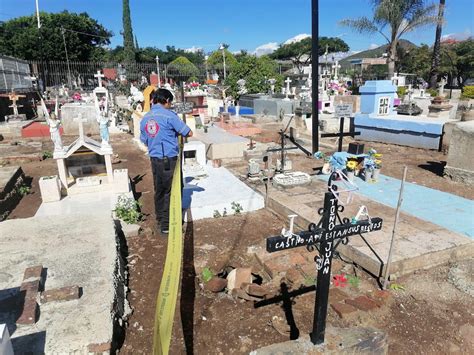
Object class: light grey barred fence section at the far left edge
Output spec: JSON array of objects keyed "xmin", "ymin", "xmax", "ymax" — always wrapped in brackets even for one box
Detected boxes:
[{"xmin": 0, "ymin": 55, "xmax": 33, "ymax": 92}]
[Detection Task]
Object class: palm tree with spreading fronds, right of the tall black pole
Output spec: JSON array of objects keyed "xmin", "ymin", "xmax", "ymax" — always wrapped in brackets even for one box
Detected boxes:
[{"xmin": 340, "ymin": 0, "xmax": 437, "ymax": 78}]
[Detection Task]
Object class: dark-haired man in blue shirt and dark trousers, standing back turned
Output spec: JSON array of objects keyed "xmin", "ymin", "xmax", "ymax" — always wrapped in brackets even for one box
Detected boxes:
[{"xmin": 140, "ymin": 89, "xmax": 193, "ymax": 234}]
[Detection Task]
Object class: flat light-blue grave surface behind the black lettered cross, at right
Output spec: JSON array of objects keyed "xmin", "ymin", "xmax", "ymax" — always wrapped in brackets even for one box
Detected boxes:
[{"xmin": 318, "ymin": 175, "xmax": 474, "ymax": 239}]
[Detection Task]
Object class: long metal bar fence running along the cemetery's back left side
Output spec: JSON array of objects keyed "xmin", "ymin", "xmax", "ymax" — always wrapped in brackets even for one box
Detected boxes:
[{"xmin": 0, "ymin": 56, "xmax": 288, "ymax": 92}]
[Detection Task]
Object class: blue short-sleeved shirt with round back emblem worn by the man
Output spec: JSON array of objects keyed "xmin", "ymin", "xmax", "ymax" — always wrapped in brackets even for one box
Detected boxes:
[{"xmin": 140, "ymin": 104, "xmax": 191, "ymax": 159}]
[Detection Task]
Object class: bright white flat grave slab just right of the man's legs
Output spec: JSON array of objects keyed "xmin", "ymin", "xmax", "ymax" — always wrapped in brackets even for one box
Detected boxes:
[{"xmin": 183, "ymin": 165, "xmax": 265, "ymax": 220}]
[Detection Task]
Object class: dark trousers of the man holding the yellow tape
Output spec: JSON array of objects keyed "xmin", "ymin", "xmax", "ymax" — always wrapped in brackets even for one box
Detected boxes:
[{"xmin": 151, "ymin": 157, "xmax": 177, "ymax": 229}]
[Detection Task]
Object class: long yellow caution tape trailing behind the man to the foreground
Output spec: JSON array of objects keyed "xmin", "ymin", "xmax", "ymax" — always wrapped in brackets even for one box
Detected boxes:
[{"xmin": 153, "ymin": 145, "xmax": 183, "ymax": 355}]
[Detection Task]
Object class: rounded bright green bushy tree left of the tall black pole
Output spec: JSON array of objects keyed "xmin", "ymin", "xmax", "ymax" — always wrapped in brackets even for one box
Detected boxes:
[{"xmin": 226, "ymin": 55, "xmax": 283, "ymax": 98}]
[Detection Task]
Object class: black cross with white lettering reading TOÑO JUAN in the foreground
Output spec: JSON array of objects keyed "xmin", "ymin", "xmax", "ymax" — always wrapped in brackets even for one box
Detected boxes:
[{"xmin": 267, "ymin": 172, "xmax": 382, "ymax": 344}]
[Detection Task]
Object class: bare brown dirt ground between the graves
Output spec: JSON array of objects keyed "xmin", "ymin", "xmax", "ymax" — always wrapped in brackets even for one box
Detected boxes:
[{"xmin": 4, "ymin": 135, "xmax": 474, "ymax": 354}]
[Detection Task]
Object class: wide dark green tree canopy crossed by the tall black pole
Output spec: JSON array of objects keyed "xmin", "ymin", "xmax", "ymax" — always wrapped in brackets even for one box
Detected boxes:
[{"xmin": 270, "ymin": 37, "xmax": 349, "ymax": 71}]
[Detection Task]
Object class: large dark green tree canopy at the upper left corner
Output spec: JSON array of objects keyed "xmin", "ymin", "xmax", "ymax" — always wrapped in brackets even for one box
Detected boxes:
[{"xmin": 0, "ymin": 11, "xmax": 112, "ymax": 61}]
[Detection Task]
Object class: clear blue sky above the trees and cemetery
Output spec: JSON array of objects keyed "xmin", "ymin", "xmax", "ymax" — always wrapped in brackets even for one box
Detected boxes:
[{"xmin": 0, "ymin": 0, "xmax": 474, "ymax": 53}]
